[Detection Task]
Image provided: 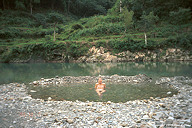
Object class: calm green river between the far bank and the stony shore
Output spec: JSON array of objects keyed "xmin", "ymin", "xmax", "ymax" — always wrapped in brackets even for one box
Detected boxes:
[{"xmin": 0, "ymin": 62, "xmax": 192, "ymax": 84}]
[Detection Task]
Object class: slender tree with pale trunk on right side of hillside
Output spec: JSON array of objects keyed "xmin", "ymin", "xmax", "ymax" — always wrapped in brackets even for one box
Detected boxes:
[{"xmin": 140, "ymin": 12, "xmax": 159, "ymax": 44}]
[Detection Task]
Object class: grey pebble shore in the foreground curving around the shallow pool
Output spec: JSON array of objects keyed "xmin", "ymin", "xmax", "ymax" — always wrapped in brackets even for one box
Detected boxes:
[{"xmin": 0, "ymin": 77, "xmax": 192, "ymax": 128}]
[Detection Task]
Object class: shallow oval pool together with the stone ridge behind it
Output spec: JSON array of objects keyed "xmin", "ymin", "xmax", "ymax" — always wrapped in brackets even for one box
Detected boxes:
[{"xmin": 28, "ymin": 74, "xmax": 177, "ymax": 103}]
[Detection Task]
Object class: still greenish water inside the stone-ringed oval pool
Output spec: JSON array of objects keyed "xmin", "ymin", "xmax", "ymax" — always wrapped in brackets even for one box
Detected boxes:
[{"xmin": 29, "ymin": 83, "xmax": 177, "ymax": 102}]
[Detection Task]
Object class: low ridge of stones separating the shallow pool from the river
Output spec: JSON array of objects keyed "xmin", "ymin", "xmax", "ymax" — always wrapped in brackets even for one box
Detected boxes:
[{"xmin": 29, "ymin": 74, "xmax": 152, "ymax": 86}]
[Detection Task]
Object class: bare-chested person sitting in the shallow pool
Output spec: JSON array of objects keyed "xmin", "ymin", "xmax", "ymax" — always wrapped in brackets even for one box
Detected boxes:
[{"xmin": 95, "ymin": 77, "xmax": 106, "ymax": 98}]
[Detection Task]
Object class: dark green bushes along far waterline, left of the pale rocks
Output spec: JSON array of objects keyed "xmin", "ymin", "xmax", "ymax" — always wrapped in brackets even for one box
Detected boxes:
[{"xmin": 2, "ymin": 42, "xmax": 89, "ymax": 62}]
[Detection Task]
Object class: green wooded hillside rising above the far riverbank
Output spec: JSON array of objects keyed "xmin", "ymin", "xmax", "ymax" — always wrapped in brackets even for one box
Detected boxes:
[{"xmin": 0, "ymin": 0, "xmax": 192, "ymax": 62}]
